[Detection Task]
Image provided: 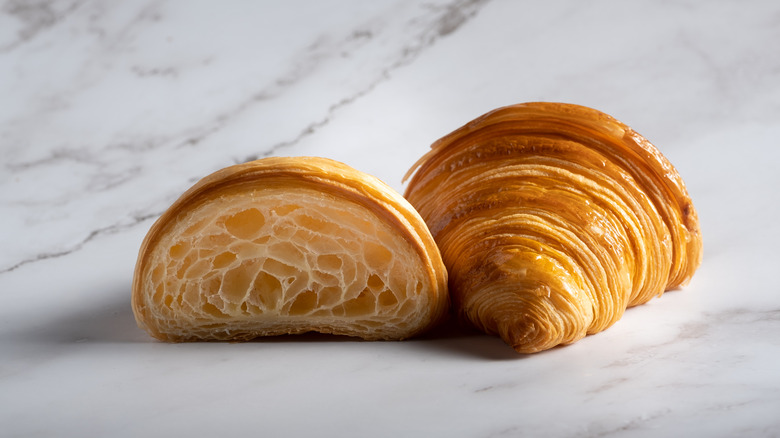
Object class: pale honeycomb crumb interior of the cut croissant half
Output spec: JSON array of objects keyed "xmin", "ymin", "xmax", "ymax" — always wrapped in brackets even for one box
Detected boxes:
[{"xmin": 141, "ymin": 188, "xmax": 431, "ymax": 340}]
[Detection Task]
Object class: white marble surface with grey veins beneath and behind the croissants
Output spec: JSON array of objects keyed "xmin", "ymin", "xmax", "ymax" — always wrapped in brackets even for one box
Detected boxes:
[{"xmin": 0, "ymin": 0, "xmax": 780, "ymax": 437}]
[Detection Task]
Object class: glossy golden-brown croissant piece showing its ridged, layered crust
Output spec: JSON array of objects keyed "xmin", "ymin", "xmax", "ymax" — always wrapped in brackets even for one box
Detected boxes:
[{"xmin": 405, "ymin": 103, "xmax": 702, "ymax": 353}]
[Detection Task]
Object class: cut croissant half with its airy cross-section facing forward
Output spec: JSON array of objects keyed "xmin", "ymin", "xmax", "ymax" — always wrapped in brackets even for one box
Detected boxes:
[{"xmin": 132, "ymin": 157, "xmax": 449, "ymax": 342}]
